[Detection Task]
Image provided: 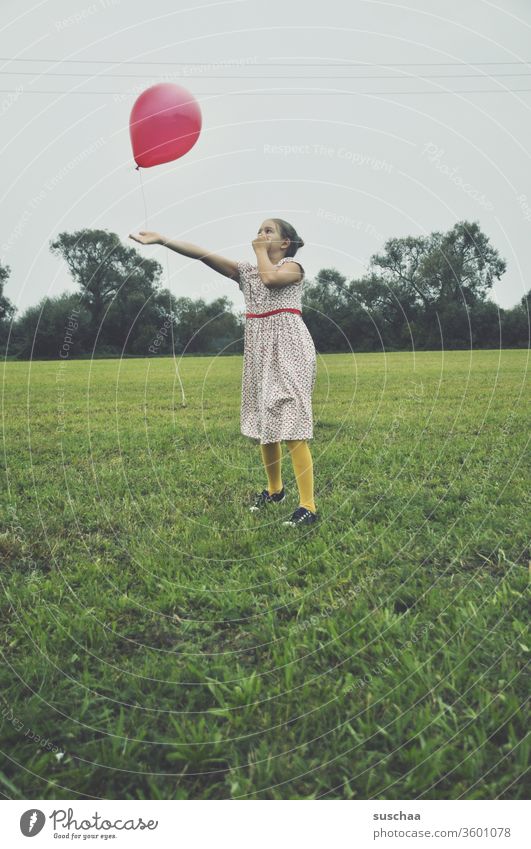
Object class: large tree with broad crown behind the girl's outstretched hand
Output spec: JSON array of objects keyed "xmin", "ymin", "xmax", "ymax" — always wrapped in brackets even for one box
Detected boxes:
[{"xmin": 50, "ymin": 230, "xmax": 162, "ymax": 333}]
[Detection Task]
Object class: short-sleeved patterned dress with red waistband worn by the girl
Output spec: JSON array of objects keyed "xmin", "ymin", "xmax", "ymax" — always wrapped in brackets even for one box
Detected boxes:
[{"xmin": 238, "ymin": 256, "xmax": 317, "ymax": 445}]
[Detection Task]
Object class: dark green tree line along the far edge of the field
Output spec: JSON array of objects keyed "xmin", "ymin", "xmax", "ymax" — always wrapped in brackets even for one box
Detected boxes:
[{"xmin": 0, "ymin": 221, "xmax": 531, "ymax": 359}]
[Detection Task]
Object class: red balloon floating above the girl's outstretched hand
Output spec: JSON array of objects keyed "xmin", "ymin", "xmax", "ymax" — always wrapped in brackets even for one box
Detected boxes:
[{"xmin": 129, "ymin": 83, "xmax": 201, "ymax": 168}]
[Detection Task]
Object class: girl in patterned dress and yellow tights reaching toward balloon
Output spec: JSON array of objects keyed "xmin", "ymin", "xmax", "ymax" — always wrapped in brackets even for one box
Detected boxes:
[{"xmin": 130, "ymin": 218, "xmax": 318, "ymax": 526}]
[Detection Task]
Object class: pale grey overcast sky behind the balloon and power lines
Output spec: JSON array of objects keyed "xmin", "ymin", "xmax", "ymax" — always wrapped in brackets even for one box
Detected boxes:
[{"xmin": 0, "ymin": 0, "xmax": 531, "ymax": 309}]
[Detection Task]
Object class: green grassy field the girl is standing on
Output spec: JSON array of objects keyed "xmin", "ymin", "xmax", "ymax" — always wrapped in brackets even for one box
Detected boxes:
[{"xmin": 0, "ymin": 350, "xmax": 531, "ymax": 799}]
